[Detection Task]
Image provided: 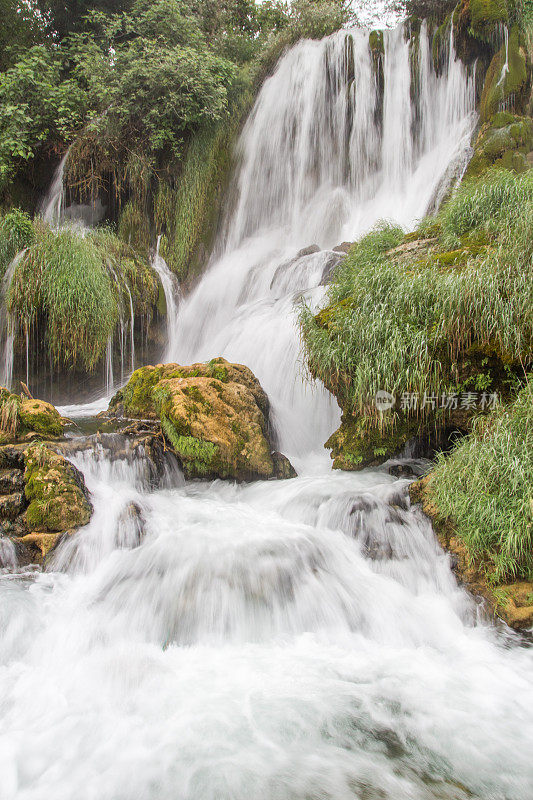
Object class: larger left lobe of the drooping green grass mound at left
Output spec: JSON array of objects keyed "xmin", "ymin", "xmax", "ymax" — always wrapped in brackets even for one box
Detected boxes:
[{"xmin": 8, "ymin": 230, "xmax": 118, "ymax": 369}]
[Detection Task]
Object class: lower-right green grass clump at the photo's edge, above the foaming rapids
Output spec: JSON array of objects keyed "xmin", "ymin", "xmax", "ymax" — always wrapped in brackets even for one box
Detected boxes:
[{"xmin": 431, "ymin": 379, "xmax": 533, "ymax": 582}]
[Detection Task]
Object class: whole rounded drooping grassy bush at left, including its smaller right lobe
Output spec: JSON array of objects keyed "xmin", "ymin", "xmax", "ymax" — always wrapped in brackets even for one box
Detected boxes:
[{"xmin": 7, "ymin": 226, "xmax": 159, "ymax": 370}]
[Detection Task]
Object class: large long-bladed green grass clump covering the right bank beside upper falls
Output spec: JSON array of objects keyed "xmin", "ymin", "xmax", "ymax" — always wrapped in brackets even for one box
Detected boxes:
[{"xmin": 301, "ymin": 174, "xmax": 533, "ymax": 422}]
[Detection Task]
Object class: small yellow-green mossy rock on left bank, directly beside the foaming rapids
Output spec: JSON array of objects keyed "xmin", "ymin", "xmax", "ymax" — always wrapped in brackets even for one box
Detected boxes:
[{"xmin": 24, "ymin": 444, "xmax": 92, "ymax": 533}]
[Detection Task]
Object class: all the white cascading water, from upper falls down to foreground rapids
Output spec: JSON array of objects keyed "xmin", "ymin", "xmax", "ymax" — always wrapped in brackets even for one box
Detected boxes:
[{"xmin": 0, "ymin": 23, "xmax": 533, "ymax": 800}]
